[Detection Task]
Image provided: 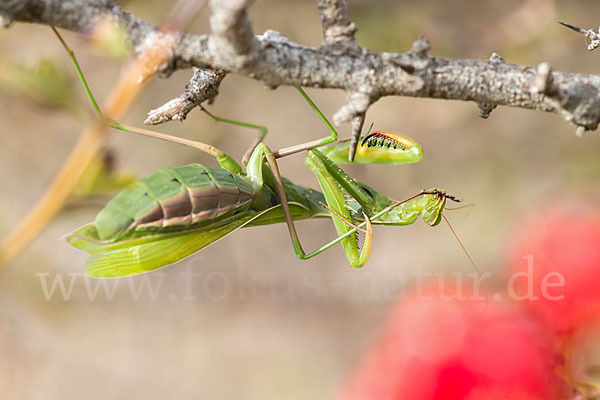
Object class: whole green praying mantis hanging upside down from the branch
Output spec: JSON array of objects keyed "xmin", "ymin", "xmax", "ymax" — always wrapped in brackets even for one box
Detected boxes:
[{"xmin": 55, "ymin": 30, "xmax": 460, "ymax": 278}]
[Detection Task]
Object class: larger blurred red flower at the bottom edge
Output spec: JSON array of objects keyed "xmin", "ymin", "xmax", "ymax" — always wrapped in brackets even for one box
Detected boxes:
[{"xmin": 342, "ymin": 291, "xmax": 564, "ymax": 400}]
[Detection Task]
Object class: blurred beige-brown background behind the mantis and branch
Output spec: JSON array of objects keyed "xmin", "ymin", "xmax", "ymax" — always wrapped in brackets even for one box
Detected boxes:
[{"xmin": 0, "ymin": 0, "xmax": 600, "ymax": 400}]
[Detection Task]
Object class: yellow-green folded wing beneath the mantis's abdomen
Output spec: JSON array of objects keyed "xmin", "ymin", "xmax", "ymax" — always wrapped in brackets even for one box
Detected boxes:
[{"xmin": 67, "ymin": 203, "xmax": 309, "ymax": 278}]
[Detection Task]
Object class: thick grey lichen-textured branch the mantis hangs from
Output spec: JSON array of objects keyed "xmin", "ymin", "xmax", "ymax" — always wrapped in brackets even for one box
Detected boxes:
[{"xmin": 0, "ymin": 0, "xmax": 600, "ymax": 147}]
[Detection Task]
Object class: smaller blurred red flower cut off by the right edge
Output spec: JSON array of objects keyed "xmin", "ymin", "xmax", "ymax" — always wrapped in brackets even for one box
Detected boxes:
[{"xmin": 509, "ymin": 204, "xmax": 600, "ymax": 331}]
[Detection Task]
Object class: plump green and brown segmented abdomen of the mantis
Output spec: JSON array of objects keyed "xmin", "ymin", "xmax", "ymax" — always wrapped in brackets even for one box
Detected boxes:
[{"xmin": 94, "ymin": 164, "xmax": 255, "ymax": 240}]
